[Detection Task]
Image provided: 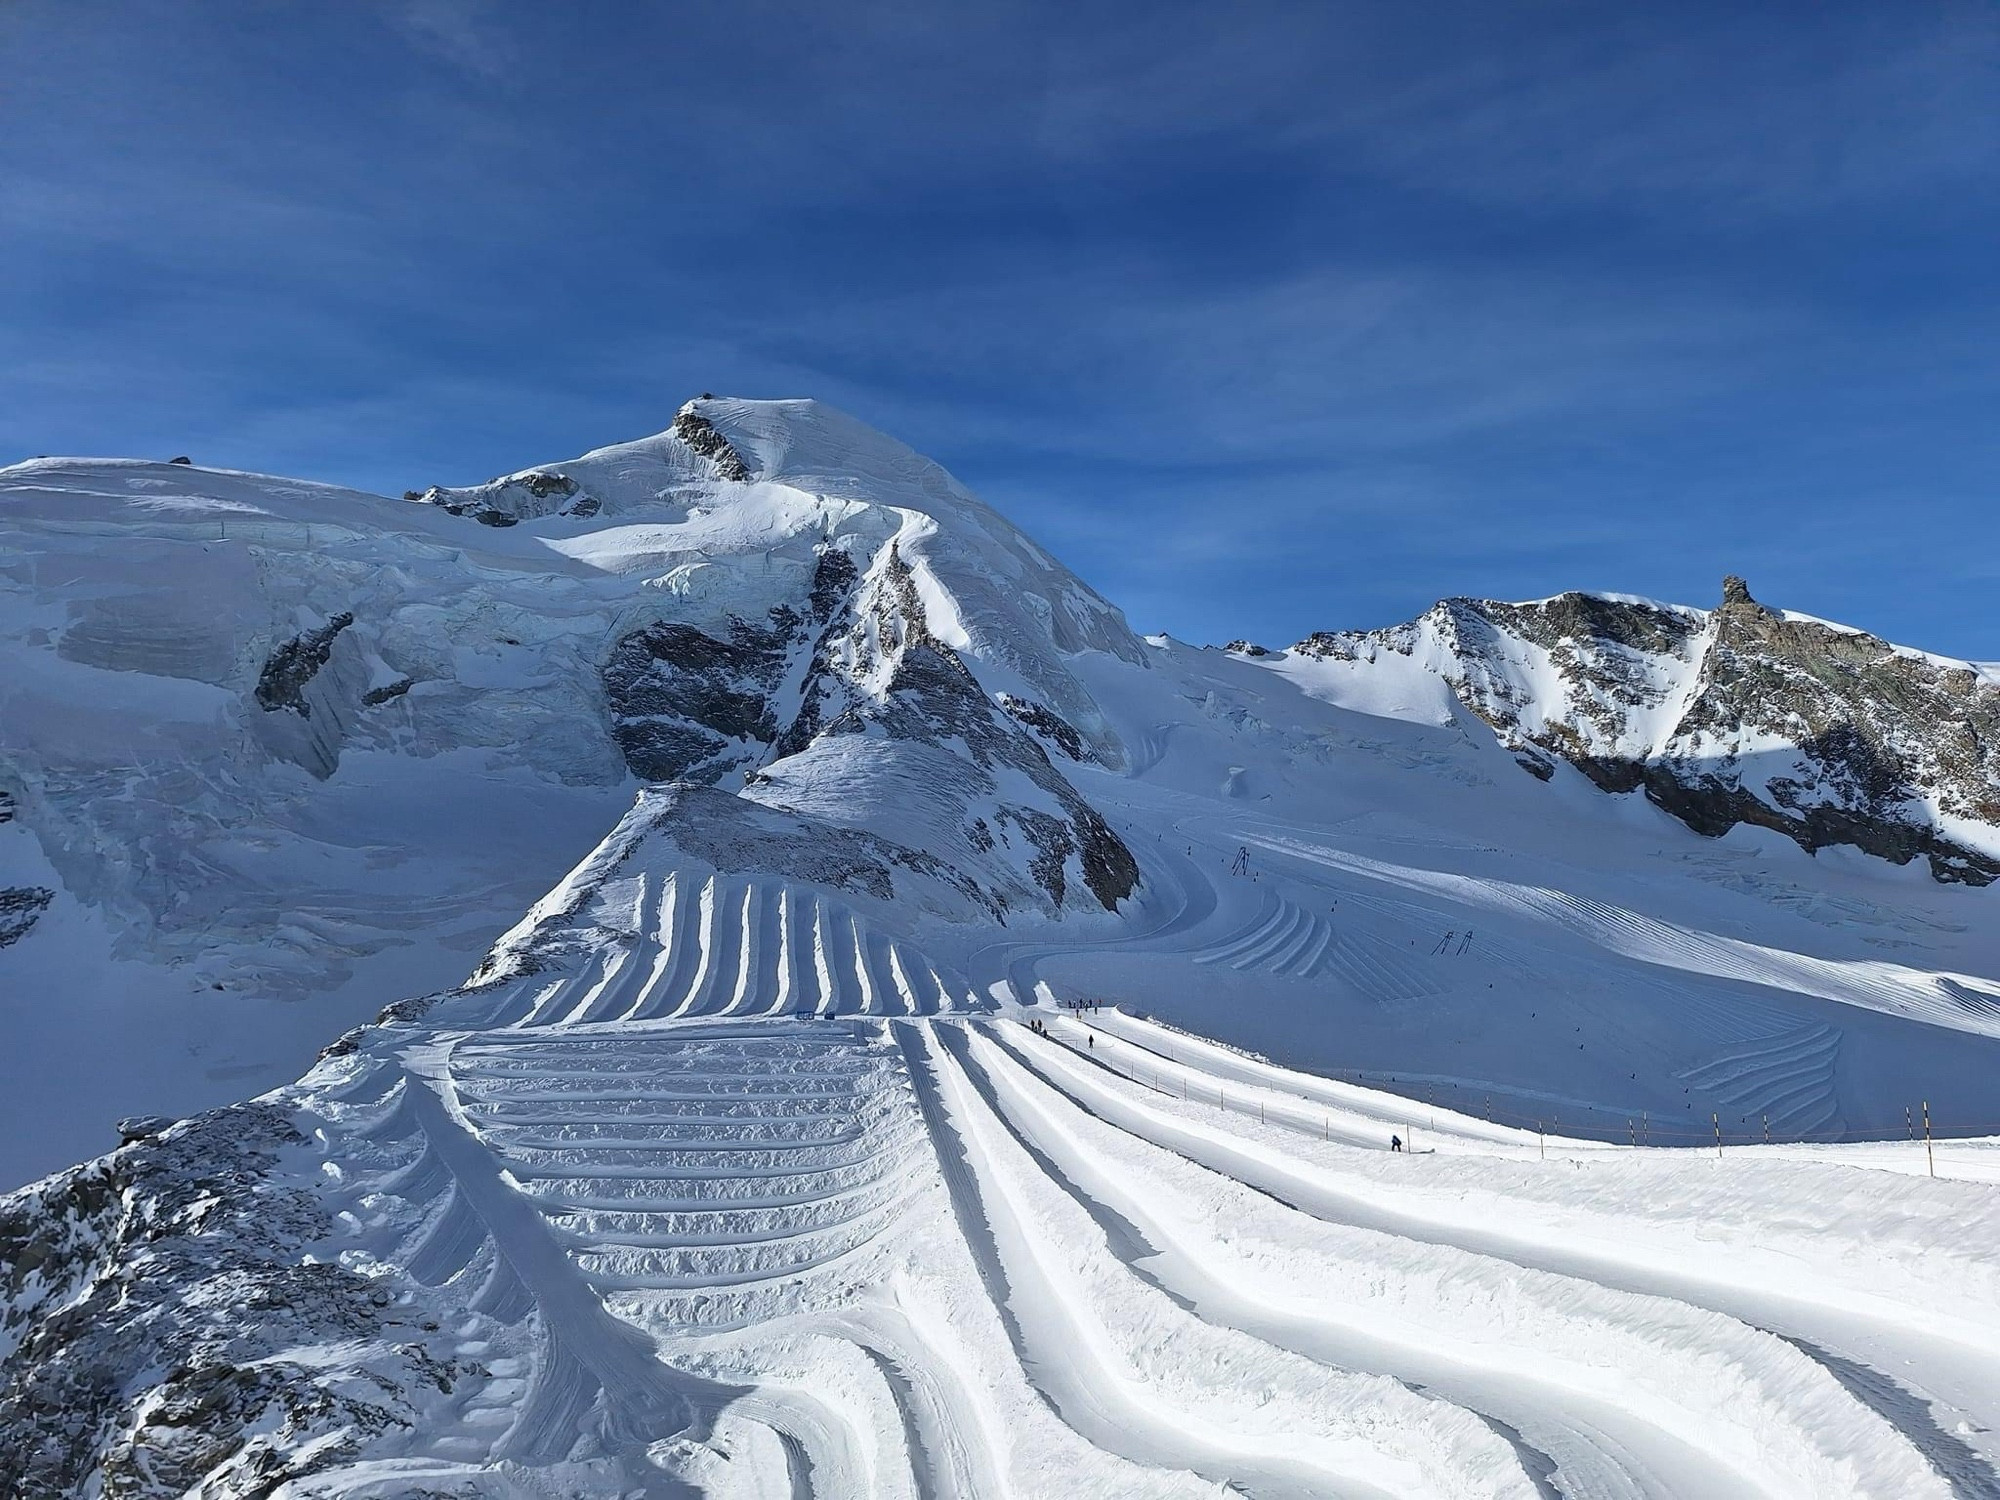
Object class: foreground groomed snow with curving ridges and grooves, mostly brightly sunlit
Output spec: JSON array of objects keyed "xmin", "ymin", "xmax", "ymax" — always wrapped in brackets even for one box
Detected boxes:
[{"xmin": 286, "ymin": 992, "xmax": 2000, "ymax": 1496}]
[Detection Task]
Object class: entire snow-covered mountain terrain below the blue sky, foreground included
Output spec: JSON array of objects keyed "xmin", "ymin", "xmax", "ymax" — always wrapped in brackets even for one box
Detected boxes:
[{"xmin": 0, "ymin": 398, "xmax": 2000, "ymax": 1500}]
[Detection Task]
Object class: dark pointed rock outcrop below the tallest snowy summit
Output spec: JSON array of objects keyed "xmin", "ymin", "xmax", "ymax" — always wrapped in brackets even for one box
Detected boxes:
[{"xmin": 584, "ymin": 524, "xmax": 1138, "ymax": 916}]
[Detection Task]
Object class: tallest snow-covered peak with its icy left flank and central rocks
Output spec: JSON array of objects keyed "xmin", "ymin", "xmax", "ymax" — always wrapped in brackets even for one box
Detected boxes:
[{"xmin": 0, "ymin": 400, "xmax": 1144, "ymax": 1182}]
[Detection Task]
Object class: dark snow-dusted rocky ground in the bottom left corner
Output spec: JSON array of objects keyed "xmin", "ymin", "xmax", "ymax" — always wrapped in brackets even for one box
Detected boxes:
[{"xmin": 0, "ymin": 1104, "xmax": 472, "ymax": 1500}]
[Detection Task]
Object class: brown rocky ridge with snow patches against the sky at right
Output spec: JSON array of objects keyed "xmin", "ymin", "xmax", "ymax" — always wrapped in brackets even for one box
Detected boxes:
[{"xmin": 1294, "ymin": 576, "xmax": 2000, "ymax": 884}]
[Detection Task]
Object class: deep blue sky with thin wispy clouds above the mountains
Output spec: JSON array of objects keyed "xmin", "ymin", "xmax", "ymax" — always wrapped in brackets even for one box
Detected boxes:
[{"xmin": 0, "ymin": 0, "xmax": 2000, "ymax": 658}]
